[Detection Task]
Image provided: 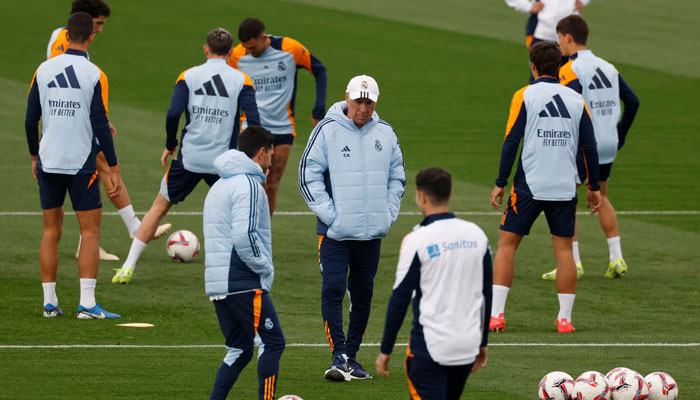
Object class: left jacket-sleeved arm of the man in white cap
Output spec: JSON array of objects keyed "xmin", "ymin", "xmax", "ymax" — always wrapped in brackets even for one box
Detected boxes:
[{"xmin": 299, "ymin": 120, "xmax": 338, "ymax": 226}]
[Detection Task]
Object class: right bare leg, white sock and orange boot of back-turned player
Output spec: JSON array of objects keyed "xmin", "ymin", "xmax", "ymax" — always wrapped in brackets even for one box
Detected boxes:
[{"xmin": 552, "ymin": 235, "xmax": 576, "ymax": 333}]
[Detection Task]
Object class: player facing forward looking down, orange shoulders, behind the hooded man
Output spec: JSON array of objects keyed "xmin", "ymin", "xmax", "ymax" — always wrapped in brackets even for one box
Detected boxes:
[{"xmin": 228, "ymin": 18, "xmax": 327, "ymax": 214}]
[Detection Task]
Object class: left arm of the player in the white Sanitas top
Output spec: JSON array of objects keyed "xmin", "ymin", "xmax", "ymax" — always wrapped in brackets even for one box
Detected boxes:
[{"xmin": 375, "ymin": 238, "xmax": 421, "ymax": 377}]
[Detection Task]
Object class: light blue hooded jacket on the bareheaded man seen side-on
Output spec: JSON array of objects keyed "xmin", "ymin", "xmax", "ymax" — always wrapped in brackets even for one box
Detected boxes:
[{"xmin": 204, "ymin": 150, "xmax": 274, "ymax": 296}]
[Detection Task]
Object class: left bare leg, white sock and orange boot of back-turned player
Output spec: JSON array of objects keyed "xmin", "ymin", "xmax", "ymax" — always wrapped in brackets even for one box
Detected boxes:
[{"xmin": 489, "ymin": 230, "xmax": 523, "ymax": 332}]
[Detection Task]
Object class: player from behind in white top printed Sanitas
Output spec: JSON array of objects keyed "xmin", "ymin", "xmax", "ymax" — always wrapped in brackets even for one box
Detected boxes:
[{"xmin": 375, "ymin": 167, "xmax": 493, "ymax": 400}]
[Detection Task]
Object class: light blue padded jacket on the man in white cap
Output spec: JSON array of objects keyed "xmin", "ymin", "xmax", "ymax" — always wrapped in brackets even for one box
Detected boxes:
[{"xmin": 299, "ymin": 101, "xmax": 406, "ymax": 240}]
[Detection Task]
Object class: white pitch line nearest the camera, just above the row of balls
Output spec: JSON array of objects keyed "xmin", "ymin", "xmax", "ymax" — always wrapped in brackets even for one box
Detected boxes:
[{"xmin": 0, "ymin": 343, "xmax": 700, "ymax": 349}]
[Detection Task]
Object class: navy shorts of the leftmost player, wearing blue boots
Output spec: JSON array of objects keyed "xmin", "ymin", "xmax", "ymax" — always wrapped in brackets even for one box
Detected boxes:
[{"xmin": 36, "ymin": 169, "xmax": 102, "ymax": 211}]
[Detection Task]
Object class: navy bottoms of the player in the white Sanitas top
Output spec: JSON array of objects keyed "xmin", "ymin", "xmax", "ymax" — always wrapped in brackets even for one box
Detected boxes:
[{"xmin": 405, "ymin": 332, "xmax": 474, "ymax": 400}]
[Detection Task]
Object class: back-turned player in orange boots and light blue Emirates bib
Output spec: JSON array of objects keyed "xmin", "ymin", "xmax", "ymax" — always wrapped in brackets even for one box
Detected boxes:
[{"xmin": 489, "ymin": 42, "xmax": 600, "ymax": 333}]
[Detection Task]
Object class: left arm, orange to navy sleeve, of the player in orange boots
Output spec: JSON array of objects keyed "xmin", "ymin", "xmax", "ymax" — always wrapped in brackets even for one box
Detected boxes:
[{"xmin": 491, "ymin": 88, "xmax": 527, "ymax": 210}]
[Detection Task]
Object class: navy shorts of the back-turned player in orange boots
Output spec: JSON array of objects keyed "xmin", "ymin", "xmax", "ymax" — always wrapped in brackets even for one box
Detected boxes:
[{"xmin": 501, "ymin": 193, "xmax": 578, "ymax": 237}]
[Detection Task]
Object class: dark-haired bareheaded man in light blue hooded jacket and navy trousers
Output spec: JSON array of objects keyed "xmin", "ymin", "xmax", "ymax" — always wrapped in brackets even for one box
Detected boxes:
[{"xmin": 203, "ymin": 126, "xmax": 285, "ymax": 400}]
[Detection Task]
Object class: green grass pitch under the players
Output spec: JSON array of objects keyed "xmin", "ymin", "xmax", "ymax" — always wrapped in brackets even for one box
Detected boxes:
[{"xmin": 0, "ymin": 0, "xmax": 700, "ymax": 400}]
